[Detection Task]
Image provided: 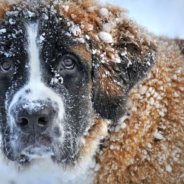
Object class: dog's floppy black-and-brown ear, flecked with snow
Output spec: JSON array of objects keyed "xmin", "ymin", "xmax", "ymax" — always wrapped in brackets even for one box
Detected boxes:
[{"xmin": 92, "ymin": 31, "xmax": 156, "ymax": 122}]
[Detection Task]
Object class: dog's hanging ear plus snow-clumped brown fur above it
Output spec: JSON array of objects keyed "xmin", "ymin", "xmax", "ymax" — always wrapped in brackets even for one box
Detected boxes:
[{"xmin": 59, "ymin": 0, "xmax": 156, "ymax": 122}]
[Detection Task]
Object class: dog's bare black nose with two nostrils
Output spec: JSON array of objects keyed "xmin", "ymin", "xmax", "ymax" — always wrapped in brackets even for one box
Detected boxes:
[{"xmin": 17, "ymin": 107, "xmax": 54, "ymax": 134}]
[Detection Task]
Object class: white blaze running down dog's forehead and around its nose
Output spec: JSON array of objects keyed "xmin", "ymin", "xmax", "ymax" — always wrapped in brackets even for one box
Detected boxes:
[{"xmin": 8, "ymin": 23, "xmax": 65, "ymax": 129}]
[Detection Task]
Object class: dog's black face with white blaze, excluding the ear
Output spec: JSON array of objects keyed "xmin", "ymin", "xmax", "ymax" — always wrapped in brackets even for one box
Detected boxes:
[{"xmin": 0, "ymin": 6, "xmax": 92, "ymax": 166}]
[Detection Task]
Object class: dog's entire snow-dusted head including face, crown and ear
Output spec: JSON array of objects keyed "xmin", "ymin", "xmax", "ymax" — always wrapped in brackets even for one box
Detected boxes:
[{"xmin": 0, "ymin": 1, "xmax": 155, "ymax": 170}]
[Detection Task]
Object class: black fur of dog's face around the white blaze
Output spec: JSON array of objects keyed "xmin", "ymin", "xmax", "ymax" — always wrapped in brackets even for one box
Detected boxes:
[{"xmin": 0, "ymin": 8, "xmax": 93, "ymax": 165}]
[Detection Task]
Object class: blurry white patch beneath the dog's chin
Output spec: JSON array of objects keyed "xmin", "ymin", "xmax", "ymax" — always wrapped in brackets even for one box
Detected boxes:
[{"xmin": 0, "ymin": 157, "xmax": 95, "ymax": 184}]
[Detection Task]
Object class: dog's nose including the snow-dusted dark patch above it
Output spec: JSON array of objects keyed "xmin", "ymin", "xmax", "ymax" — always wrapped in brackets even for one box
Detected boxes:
[{"xmin": 11, "ymin": 101, "xmax": 57, "ymax": 134}]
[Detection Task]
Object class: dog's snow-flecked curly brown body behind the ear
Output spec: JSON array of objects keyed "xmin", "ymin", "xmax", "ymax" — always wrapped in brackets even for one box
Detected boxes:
[{"xmin": 96, "ymin": 38, "xmax": 184, "ymax": 183}]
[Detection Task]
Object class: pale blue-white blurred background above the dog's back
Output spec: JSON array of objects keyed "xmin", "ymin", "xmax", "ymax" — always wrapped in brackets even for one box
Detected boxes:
[{"xmin": 101, "ymin": 0, "xmax": 184, "ymax": 39}]
